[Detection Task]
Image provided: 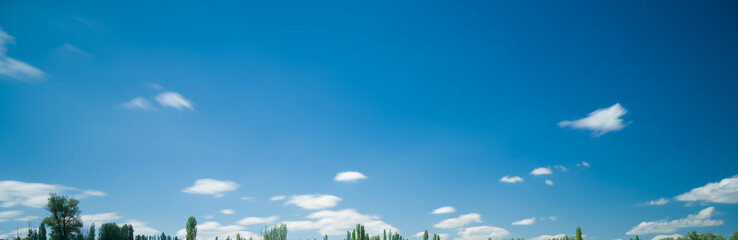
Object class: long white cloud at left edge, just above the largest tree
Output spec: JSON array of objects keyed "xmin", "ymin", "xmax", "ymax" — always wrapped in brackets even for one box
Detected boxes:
[{"xmin": 0, "ymin": 181, "xmax": 105, "ymax": 208}]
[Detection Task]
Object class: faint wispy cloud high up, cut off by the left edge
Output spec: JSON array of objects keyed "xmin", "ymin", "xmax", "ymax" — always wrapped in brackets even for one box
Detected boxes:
[{"xmin": 0, "ymin": 28, "xmax": 46, "ymax": 82}]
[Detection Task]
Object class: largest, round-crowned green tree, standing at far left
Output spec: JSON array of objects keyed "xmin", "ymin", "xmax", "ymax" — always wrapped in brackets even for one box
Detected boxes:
[{"xmin": 43, "ymin": 193, "xmax": 82, "ymax": 240}]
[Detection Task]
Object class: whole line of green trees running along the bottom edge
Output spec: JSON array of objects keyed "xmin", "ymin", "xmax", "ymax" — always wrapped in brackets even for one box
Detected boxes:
[{"xmin": 7, "ymin": 193, "xmax": 738, "ymax": 240}]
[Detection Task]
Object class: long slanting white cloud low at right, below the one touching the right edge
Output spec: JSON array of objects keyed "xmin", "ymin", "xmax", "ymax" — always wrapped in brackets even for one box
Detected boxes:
[{"xmin": 626, "ymin": 207, "xmax": 723, "ymax": 235}]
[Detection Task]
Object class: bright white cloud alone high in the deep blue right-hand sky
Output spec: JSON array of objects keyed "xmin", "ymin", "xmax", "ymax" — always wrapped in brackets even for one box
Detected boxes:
[{"xmin": 559, "ymin": 103, "xmax": 628, "ymax": 136}]
